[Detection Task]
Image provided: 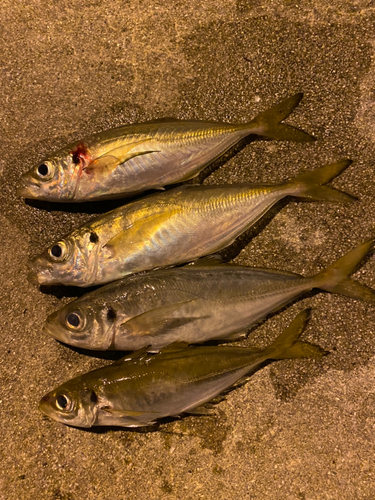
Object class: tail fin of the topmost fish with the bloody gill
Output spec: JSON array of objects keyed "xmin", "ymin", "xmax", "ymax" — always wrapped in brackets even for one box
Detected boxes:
[{"xmin": 247, "ymin": 93, "xmax": 316, "ymax": 142}]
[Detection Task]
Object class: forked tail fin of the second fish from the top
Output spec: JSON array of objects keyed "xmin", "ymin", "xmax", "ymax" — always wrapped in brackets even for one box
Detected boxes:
[{"xmin": 285, "ymin": 160, "xmax": 357, "ymax": 203}]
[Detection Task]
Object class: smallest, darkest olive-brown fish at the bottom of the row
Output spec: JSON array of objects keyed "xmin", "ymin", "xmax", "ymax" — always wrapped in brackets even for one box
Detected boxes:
[{"xmin": 39, "ymin": 310, "xmax": 327, "ymax": 428}]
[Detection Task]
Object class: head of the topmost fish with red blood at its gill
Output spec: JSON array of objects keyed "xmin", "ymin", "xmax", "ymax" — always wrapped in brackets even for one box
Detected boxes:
[{"xmin": 17, "ymin": 141, "xmax": 92, "ymax": 202}]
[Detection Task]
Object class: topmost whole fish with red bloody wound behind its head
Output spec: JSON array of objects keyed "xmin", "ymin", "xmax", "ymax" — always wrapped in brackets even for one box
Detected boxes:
[{"xmin": 17, "ymin": 93, "xmax": 315, "ymax": 203}]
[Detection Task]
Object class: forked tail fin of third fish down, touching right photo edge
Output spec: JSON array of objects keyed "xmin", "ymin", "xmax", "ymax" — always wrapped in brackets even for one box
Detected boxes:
[{"xmin": 313, "ymin": 238, "xmax": 375, "ymax": 304}]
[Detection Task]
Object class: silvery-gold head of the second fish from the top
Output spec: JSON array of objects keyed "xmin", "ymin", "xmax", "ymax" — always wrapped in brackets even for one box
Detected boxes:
[{"xmin": 29, "ymin": 228, "xmax": 99, "ymax": 287}]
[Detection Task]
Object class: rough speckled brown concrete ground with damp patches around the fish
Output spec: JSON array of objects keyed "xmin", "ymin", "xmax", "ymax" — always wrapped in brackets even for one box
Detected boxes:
[{"xmin": 0, "ymin": 0, "xmax": 375, "ymax": 500}]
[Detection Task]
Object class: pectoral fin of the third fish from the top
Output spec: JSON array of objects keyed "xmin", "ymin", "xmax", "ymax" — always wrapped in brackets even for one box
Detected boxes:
[{"xmin": 121, "ymin": 299, "xmax": 197, "ymax": 335}]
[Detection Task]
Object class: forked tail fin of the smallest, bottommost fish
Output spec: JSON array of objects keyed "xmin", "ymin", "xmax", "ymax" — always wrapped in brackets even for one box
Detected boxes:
[{"xmin": 264, "ymin": 309, "xmax": 329, "ymax": 359}]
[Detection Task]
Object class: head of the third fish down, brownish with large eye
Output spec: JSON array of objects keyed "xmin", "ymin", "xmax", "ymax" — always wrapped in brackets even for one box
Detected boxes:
[{"xmin": 43, "ymin": 297, "xmax": 116, "ymax": 351}]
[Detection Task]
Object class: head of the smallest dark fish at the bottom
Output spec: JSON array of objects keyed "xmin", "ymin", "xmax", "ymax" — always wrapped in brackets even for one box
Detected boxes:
[{"xmin": 39, "ymin": 377, "xmax": 98, "ymax": 427}]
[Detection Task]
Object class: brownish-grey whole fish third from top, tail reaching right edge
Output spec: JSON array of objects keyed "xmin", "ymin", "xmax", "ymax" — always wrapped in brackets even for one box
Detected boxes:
[{"xmin": 43, "ymin": 239, "xmax": 375, "ymax": 351}]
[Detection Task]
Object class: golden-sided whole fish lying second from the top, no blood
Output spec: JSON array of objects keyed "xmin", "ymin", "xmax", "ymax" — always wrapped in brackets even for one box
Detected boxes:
[{"xmin": 29, "ymin": 160, "xmax": 354, "ymax": 287}]
